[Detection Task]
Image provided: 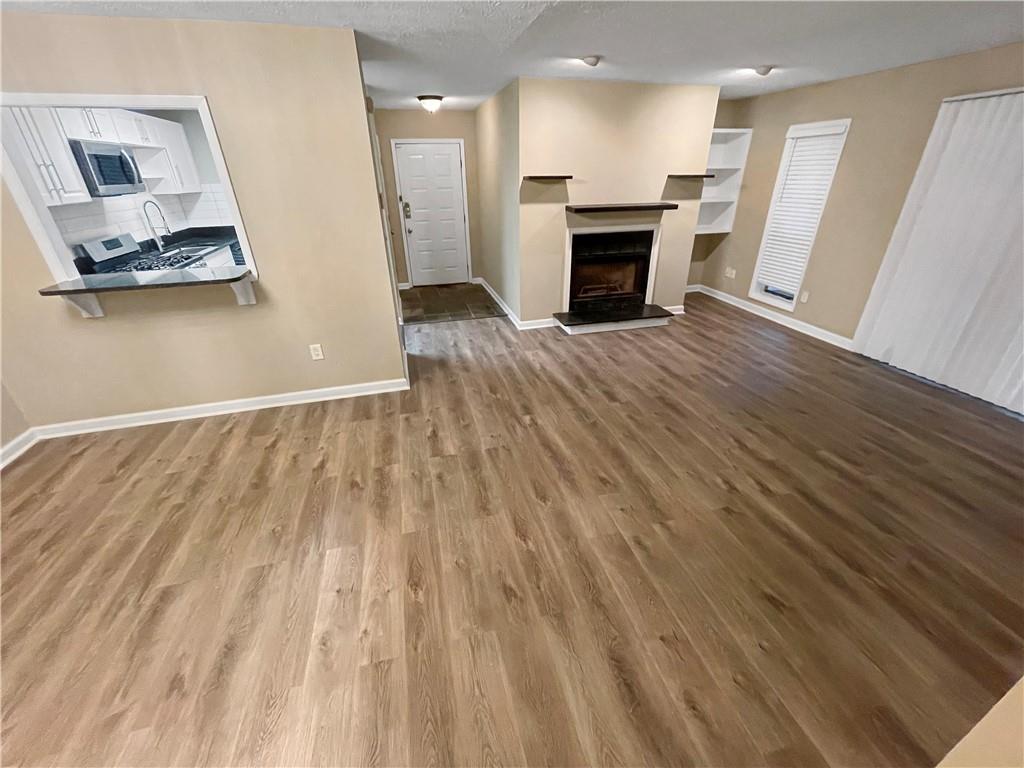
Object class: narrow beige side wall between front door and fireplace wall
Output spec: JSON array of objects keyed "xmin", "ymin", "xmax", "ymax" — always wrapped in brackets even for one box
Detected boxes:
[{"xmin": 473, "ymin": 81, "xmax": 521, "ymax": 314}]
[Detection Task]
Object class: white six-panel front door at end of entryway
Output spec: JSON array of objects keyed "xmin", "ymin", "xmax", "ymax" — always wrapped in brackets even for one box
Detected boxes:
[{"xmin": 395, "ymin": 141, "xmax": 469, "ymax": 286}]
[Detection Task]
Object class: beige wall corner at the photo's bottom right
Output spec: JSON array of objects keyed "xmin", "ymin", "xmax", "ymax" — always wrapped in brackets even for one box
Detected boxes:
[{"xmin": 939, "ymin": 680, "xmax": 1024, "ymax": 768}]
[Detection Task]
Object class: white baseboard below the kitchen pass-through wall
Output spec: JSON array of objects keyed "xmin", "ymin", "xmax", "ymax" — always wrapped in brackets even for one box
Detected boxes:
[{"xmin": 0, "ymin": 379, "xmax": 409, "ymax": 467}]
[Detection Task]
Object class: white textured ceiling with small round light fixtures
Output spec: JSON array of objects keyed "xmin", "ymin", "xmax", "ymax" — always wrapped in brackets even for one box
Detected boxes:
[{"xmin": 4, "ymin": 0, "xmax": 1024, "ymax": 109}]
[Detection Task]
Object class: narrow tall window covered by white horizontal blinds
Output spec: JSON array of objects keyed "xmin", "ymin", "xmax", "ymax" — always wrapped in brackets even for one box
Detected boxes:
[{"xmin": 750, "ymin": 120, "xmax": 850, "ymax": 312}]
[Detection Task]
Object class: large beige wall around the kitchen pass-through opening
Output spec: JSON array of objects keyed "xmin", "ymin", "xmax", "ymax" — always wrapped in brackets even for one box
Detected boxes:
[{"xmin": 2, "ymin": 12, "xmax": 403, "ymax": 434}]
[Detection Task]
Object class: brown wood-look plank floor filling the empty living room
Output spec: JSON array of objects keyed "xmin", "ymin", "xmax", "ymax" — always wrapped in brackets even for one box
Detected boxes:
[{"xmin": 2, "ymin": 296, "xmax": 1024, "ymax": 766}]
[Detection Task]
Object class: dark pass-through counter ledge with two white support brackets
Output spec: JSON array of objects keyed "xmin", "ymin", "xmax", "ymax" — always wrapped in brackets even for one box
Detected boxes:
[{"xmin": 39, "ymin": 266, "xmax": 256, "ymax": 317}]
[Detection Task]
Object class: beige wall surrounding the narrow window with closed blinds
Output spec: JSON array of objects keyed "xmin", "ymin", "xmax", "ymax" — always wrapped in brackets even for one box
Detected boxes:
[{"xmin": 691, "ymin": 44, "xmax": 1024, "ymax": 336}]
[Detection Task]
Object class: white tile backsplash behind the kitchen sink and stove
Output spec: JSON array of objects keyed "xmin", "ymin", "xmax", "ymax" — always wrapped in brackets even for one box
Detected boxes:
[{"xmin": 50, "ymin": 184, "xmax": 233, "ymax": 246}]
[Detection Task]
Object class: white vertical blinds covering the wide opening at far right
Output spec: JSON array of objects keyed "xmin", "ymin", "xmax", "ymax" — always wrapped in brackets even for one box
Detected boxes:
[{"xmin": 854, "ymin": 90, "xmax": 1024, "ymax": 413}]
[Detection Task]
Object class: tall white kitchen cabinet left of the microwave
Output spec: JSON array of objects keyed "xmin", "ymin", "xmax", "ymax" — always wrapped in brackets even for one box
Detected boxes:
[{"xmin": 3, "ymin": 106, "xmax": 92, "ymax": 206}]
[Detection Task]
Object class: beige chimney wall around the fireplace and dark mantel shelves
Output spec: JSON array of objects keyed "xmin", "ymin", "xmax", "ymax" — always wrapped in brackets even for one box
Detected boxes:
[{"xmin": 519, "ymin": 78, "xmax": 718, "ymax": 319}]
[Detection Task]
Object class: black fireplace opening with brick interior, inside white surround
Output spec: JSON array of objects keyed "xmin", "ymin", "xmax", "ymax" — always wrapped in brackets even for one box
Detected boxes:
[{"xmin": 568, "ymin": 229, "xmax": 654, "ymax": 314}]
